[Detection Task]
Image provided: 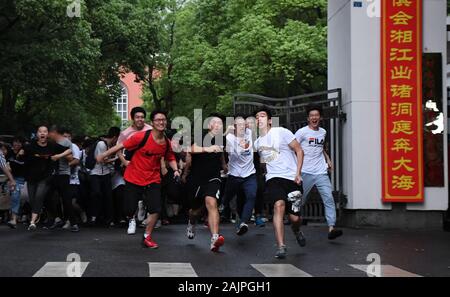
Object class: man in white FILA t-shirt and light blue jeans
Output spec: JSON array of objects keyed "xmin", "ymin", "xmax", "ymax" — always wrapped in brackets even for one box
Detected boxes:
[{"xmin": 295, "ymin": 106, "xmax": 343, "ymax": 239}]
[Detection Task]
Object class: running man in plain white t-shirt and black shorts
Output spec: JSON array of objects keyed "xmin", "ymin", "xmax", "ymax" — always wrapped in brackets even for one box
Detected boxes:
[{"xmin": 254, "ymin": 108, "xmax": 306, "ymax": 259}]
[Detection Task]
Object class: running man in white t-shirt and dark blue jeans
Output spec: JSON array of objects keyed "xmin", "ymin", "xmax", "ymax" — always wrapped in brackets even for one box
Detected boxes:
[{"xmin": 224, "ymin": 116, "xmax": 258, "ymax": 235}]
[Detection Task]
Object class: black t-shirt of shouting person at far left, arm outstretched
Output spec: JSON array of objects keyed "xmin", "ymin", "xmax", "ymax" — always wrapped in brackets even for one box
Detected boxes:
[{"xmin": 24, "ymin": 141, "xmax": 66, "ymax": 182}]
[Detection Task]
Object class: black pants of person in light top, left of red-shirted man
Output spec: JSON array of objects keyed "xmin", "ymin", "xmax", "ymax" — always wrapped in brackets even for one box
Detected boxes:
[{"xmin": 89, "ymin": 174, "xmax": 113, "ymax": 224}]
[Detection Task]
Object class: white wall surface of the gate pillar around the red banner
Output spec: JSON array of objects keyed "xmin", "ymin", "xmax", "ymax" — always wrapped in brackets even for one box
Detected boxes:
[{"xmin": 328, "ymin": 0, "xmax": 448, "ymax": 210}]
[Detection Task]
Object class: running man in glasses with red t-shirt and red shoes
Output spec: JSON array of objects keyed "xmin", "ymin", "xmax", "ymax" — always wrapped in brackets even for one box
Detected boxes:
[{"xmin": 96, "ymin": 110, "xmax": 180, "ymax": 248}]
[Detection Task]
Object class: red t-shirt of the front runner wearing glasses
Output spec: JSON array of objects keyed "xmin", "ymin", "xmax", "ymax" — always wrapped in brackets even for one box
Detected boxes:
[{"xmin": 123, "ymin": 131, "xmax": 175, "ymax": 186}]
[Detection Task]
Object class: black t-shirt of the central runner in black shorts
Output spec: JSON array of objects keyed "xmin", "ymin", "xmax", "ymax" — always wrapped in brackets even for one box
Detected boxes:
[{"xmin": 191, "ymin": 132, "xmax": 225, "ymax": 184}]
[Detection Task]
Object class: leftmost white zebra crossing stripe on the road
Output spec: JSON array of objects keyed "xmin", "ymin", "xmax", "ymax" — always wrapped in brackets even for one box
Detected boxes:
[{"xmin": 33, "ymin": 262, "xmax": 89, "ymax": 277}]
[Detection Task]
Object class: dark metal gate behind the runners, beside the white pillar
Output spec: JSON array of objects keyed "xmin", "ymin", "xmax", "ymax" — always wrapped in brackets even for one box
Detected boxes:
[{"xmin": 233, "ymin": 89, "xmax": 347, "ymax": 222}]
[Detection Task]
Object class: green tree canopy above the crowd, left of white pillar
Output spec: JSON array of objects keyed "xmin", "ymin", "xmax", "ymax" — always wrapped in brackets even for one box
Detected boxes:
[{"xmin": 0, "ymin": 0, "xmax": 326, "ymax": 134}]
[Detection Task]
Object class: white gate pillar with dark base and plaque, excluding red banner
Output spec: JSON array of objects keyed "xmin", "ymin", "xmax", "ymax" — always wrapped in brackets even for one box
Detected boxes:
[{"xmin": 328, "ymin": 0, "xmax": 450, "ymax": 228}]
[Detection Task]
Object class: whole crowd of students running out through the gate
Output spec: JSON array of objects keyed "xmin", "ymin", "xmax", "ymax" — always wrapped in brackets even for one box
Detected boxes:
[{"xmin": 0, "ymin": 106, "xmax": 342, "ymax": 258}]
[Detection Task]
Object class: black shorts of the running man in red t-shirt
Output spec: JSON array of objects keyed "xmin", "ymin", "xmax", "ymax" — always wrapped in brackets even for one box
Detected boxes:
[{"xmin": 124, "ymin": 182, "xmax": 161, "ymax": 217}]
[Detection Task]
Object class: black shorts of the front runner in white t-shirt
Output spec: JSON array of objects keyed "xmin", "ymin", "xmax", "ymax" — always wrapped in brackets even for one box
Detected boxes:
[{"xmin": 266, "ymin": 177, "xmax": 303, "ymax": 216}]
